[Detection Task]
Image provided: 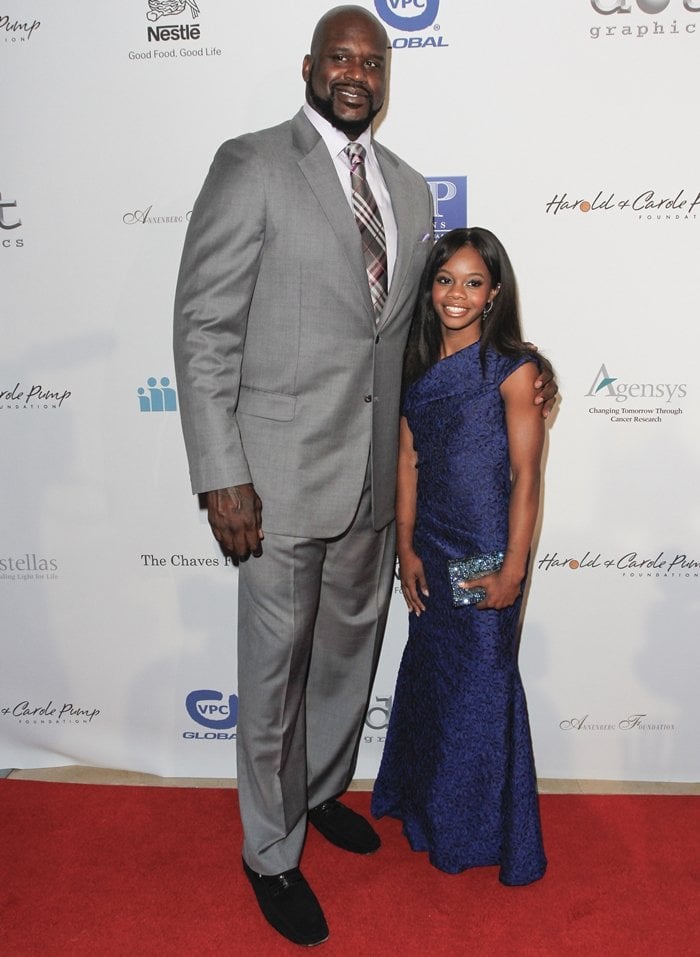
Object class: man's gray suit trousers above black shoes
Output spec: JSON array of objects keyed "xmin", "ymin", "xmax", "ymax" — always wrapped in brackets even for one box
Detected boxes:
[{"xmin": 237, "ymin": 468, "xmax": 395, "ymax": 874}]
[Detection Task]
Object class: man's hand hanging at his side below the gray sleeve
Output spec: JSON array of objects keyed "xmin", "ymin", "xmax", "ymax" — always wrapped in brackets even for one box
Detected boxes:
[{"xmin": 207, "ymin": 483, "xmax": 265, "ymax": 560}]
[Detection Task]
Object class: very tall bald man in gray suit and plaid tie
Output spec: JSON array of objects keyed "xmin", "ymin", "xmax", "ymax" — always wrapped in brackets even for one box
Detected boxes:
[{"xmin": 175, "ymin": 6, "xmax": 551, "ymax": 944}]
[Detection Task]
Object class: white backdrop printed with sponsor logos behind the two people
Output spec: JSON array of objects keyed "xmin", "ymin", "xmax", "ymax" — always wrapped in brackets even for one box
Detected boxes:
[{"xmin": 0, "ymin": 0, "xmax": 700, "ymax": 781}]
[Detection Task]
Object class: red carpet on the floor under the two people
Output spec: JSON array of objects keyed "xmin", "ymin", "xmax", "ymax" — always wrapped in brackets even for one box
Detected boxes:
[{"xmin": 0, "ymin": 780, "xmax": 700, "ymax": 957}]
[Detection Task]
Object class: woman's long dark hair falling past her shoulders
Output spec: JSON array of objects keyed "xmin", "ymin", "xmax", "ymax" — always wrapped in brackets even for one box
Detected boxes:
[{"xmin": 404, "ymin": 226, "xmax": 530, "ymax": 388}]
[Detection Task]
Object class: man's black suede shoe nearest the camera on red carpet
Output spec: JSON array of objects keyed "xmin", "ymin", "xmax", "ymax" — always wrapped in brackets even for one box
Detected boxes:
[{"xmin": 243, "ymin": 861, "xmax": 328, "ymax": 947}]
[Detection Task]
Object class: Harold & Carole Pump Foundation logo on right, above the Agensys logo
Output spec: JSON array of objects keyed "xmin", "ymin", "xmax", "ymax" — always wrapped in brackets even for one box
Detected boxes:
[{"xmin": 544, "ymin": 186, "xmax": 700, "ymax": 223}]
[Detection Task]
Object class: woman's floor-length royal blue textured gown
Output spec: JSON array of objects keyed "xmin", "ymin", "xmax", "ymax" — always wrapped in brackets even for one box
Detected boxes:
[{"xmin": 372, "ymin": 343, "xmax": 546, "ymax": 884}]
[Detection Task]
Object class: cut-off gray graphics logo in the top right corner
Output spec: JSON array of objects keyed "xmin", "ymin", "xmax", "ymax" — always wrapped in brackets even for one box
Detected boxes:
[{"xmin": 588, "ymin": 0, "xmax": 700, "ymax": 43}]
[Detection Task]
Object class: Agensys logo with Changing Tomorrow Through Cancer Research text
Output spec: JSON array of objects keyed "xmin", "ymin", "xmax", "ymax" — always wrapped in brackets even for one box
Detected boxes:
[{"xmin": 585, "ymin": 362, "xmax": 688, "ymax": 425}]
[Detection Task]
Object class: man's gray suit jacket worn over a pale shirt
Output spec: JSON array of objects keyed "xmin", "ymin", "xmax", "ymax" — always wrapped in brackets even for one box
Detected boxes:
[{"xmin": 174, "ymin": 111, "xmax": 432, "ymax": 538}]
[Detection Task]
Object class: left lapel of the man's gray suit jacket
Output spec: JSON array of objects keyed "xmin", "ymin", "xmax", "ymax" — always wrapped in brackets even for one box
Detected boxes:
[{"xmin": 292, "ymin": 112, "xmax": 374, "ymax": 318}]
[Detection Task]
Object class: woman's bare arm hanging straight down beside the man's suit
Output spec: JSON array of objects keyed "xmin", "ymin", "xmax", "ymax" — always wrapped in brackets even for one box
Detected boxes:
[{"xmin": 396, "ymin": 416, "xmax": 430, "ymax": 615}]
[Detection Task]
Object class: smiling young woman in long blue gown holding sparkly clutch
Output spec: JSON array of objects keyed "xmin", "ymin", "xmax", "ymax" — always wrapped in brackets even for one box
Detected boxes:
[{"xmin": 372, "ymin": 228, "xmax": 546, "ymax": 885}]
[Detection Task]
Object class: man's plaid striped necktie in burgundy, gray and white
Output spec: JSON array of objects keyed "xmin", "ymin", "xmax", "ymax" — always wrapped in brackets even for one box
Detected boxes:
[{"xmin": 345, "ymin": 143, "xmax": 387, "ymax": 319}]
